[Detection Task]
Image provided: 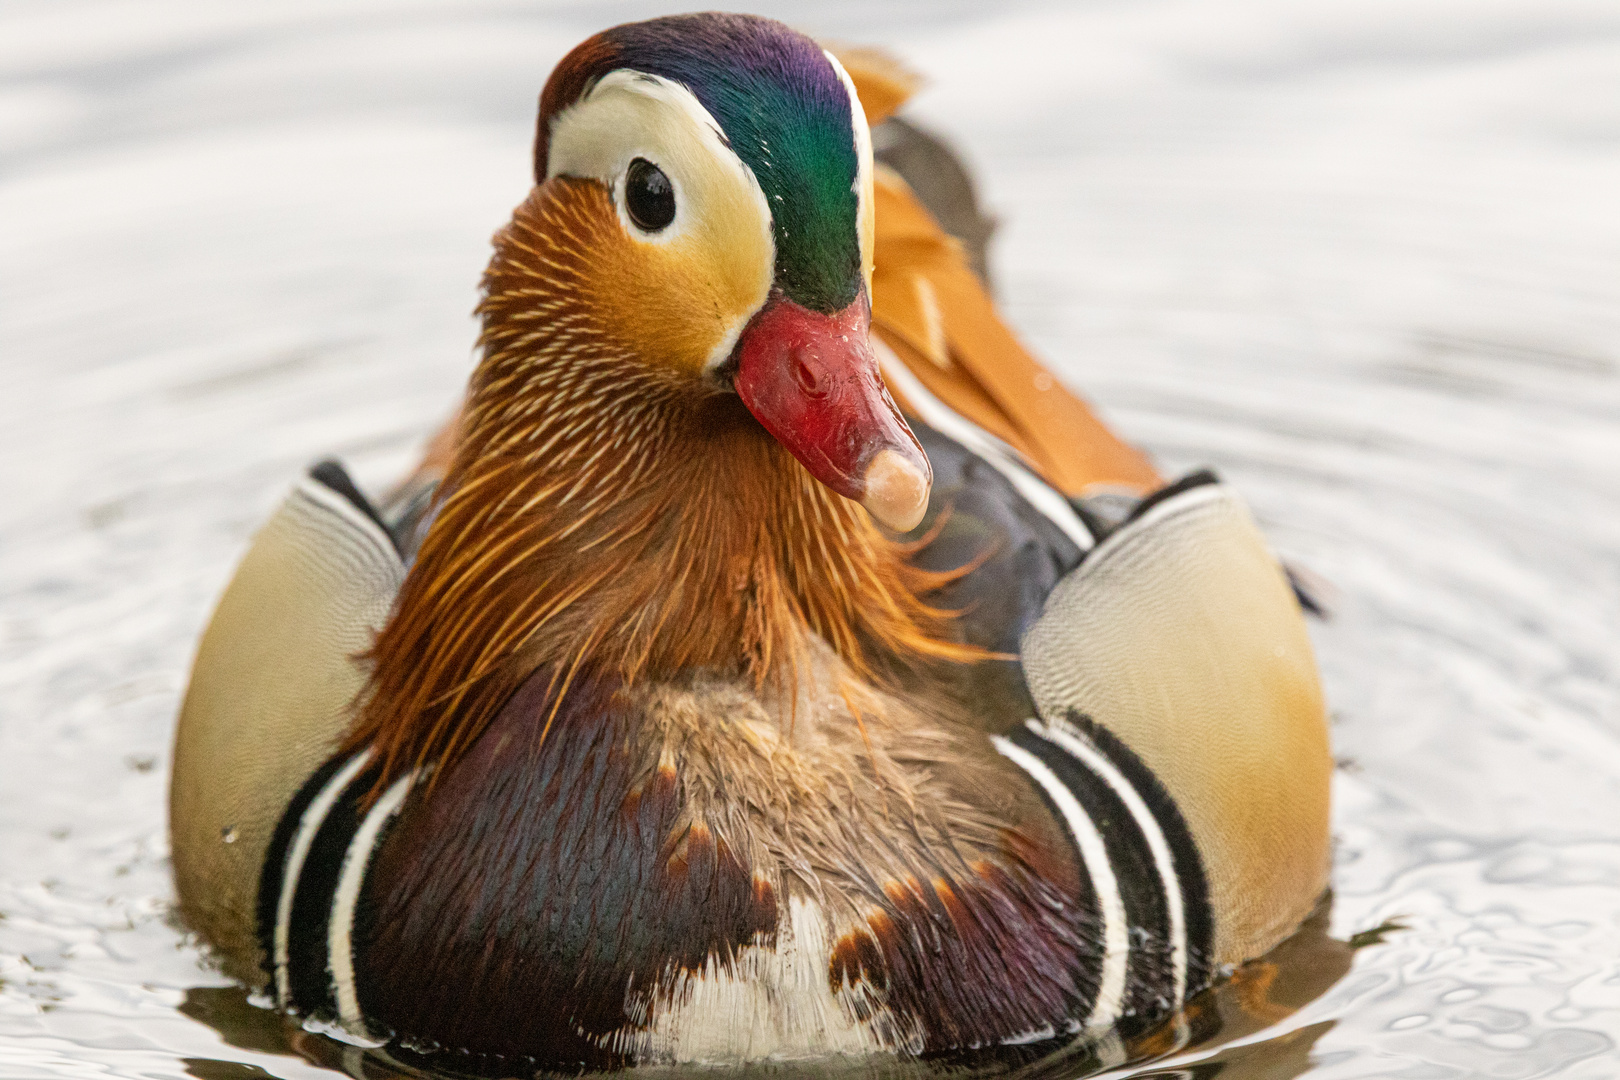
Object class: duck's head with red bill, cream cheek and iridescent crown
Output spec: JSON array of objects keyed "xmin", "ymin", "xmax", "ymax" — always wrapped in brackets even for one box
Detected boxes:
[{"xmin": 535, "ymin": 13, "xmax": 932, "ymax": 531}]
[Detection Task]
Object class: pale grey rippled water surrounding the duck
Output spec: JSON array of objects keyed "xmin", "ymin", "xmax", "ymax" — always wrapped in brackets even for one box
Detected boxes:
[{"xmin": 0, "ymin": 0, "xmax": 1620, "ymax": 1080}]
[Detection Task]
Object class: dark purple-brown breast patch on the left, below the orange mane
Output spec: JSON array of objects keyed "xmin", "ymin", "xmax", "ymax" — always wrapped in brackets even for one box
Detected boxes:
[{"xmin": 355, "ymin": 674, "xmax": 778, "ymax": 1067}]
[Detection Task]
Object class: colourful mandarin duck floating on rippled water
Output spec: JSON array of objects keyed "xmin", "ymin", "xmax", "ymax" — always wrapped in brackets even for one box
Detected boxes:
[{"xmin": 170, "ymin": 15, "xmax": 1330, "ymax": 1075}]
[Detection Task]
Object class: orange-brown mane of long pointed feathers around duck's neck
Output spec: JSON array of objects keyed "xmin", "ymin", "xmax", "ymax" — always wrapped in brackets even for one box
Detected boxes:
[{"xmin": 347, "ymin": 180, "xmax": 983, "ymax": 782}]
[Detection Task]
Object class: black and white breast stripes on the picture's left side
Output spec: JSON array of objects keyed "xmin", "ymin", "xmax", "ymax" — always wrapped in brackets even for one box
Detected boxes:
[{"xmin": 258, "ymin": 750, "xmax": 416, "ymax": 1038}]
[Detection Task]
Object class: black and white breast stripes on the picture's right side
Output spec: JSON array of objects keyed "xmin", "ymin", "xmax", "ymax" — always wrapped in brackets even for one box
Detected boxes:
[{"xmin": 991, "ymin": 714, "xmax": 1213, "ymax": 1038}]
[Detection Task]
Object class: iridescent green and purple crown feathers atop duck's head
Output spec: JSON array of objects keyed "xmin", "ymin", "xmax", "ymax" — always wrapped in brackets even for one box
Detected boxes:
[{"xmin": 535, "ymin": 11, "xmax": 860, "ymax": 313}]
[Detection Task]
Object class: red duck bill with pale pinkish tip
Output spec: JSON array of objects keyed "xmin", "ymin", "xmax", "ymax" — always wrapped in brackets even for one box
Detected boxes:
[{"xmin": 732, "ymin": 291, "xmax": 933, "ymax": 533}]
